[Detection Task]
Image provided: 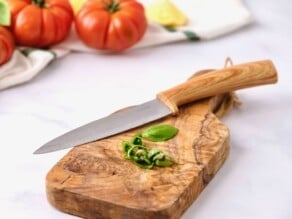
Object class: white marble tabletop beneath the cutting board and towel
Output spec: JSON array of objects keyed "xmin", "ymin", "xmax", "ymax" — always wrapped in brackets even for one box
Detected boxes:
[{"xmin": 0, "ymin": 0, "xmax": 292, "ymax": 219}]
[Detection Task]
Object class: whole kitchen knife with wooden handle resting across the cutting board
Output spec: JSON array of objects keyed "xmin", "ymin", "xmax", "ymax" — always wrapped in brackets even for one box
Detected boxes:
[{"xmin": 34, "ymin": 60, "xmax": 278, "ymax": 154}]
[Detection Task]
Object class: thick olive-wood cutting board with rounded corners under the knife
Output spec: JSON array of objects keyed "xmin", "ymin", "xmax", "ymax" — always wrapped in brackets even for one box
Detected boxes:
[{"xmin": 46, "ymin": 90, "xmax": 235, "ymax": 219}]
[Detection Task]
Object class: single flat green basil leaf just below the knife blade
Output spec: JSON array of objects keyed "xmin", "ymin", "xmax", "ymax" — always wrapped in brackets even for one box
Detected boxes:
[{"xmin": 142, "ymin": 124, "xmax": 178, "ymax": 142}]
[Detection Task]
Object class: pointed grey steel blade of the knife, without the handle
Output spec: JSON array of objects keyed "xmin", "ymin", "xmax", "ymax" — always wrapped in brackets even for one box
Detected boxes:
[{"xmin": 34, "ymin": 99, "xmax": 172, "ymax": 154}]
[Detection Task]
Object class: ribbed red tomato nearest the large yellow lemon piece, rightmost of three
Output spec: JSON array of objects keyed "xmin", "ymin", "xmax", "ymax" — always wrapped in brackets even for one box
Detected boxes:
[{"xmin": 75, "ymin": 0, "xmax": 147, "ymax": 51}]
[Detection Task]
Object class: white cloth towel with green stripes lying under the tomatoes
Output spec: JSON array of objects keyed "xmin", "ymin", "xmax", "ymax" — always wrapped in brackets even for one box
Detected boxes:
[{"xmin": 0, "ymin": 0, "xmax": 253, "ymax": 90}]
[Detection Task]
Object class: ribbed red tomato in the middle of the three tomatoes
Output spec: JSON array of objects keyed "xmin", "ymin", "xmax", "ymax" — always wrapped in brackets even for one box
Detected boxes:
[{"xmin": 7, "ymin": 0, "xmax": 73, "ymax": 47}]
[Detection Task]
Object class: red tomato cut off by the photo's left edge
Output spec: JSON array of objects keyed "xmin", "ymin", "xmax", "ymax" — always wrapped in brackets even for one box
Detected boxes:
[{"xmin": 0, "ymin": 26, "xmax": 15, "ymax": 65}]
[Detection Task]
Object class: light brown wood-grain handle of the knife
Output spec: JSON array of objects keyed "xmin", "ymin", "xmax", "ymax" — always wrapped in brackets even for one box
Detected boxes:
[{"xmin": 157, "ymin": 60, "xmax": 278, "ymax": 114}]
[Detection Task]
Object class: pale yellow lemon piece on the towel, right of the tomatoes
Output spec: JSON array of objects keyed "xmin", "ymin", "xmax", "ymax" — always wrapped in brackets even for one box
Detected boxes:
[{"xmin": 145, "ymin": 0, "xmax": 188, "ymax": 27}]
